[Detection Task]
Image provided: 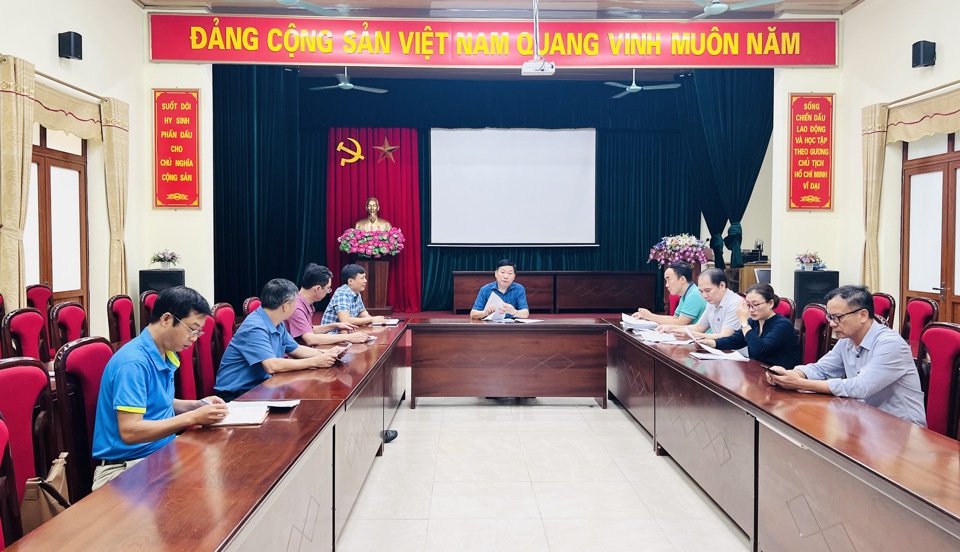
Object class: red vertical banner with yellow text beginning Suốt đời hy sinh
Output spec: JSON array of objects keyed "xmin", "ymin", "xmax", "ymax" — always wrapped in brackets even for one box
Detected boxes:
[{"xmin": 153, "ymin": 88, "xmax": 200, "ymax": 209}]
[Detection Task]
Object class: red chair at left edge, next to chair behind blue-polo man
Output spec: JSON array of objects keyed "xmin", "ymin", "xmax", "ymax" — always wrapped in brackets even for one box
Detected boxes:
[{"xmin": 0, "ymin": 357, "xmax": 55, "ymax": 502}]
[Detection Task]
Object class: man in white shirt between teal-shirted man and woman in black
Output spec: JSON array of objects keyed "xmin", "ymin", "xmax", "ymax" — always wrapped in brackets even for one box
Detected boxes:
[{"xmin": 657, "ymin": 268, "xmax": 746, "ymax": 340}]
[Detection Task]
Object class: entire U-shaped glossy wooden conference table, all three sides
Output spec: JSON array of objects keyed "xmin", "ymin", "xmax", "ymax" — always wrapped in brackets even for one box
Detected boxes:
[{"xmin": 11, "ymin": 318, "xmax": 960, "ymax": 552}]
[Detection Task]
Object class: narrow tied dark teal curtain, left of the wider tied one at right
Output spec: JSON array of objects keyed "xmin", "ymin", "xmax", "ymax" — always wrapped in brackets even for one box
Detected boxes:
[{"xmin": 676, "ymin": 75, "xmax": 727, "ymax": 268}]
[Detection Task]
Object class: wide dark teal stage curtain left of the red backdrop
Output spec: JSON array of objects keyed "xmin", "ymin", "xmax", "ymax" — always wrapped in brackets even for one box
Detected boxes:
[{"xmin": 213, "ymin": 65, "xmax": 326, "ymax": 308}]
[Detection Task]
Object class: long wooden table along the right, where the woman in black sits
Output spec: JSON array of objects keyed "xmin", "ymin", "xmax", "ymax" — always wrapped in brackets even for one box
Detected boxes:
[{"xmin": 608, "ymin": 328, "xmax": 960, "ymax": 552}]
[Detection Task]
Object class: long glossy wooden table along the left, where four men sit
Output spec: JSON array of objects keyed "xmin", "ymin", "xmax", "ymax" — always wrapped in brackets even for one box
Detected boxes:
[{"xmin": 8, "ymin": 324, "xmax": 409, "ymax": 552}]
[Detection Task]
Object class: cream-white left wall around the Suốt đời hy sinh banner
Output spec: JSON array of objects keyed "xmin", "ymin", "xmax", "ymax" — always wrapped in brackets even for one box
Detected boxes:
[{"xmin": 0, "ymin": 0, "xmax": 214, "ymax": 335}]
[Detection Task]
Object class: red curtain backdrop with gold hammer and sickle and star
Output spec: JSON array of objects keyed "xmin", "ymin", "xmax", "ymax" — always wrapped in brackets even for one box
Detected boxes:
[{"xmin": 327, "ymin": 128, "xmax": 421, "ymax": 312}]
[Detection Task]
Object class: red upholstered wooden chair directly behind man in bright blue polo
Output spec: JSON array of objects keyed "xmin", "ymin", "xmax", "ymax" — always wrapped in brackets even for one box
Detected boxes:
[{"xmin": 53, "ymin": 337, "xmax": 113, "ymax": 501}]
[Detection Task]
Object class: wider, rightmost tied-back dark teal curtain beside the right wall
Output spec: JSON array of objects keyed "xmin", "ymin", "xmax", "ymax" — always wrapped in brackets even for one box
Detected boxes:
[{"xmin": 685, "ymin": 69, "xmax": 773, "ymax": 268}]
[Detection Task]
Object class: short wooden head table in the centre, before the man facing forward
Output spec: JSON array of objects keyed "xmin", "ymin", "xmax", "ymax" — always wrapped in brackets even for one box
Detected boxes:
[{"xmin": 407, "ymin": 317, "xmax": 609, "ymax": 408}]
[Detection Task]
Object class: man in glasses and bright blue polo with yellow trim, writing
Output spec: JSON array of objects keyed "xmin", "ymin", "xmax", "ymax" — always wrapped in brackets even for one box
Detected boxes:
[{"xmin": 92, "ymin": 286, "xmax": 227, "ymax": 490}]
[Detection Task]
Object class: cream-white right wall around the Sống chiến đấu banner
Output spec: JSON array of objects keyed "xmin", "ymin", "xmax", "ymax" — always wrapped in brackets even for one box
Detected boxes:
[{"xmin": 771, "ymin": 0, "xmax": 960, "ymax": 302}]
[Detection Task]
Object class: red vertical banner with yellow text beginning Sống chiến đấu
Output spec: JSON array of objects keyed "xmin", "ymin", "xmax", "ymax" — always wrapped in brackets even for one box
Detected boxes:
[{"xmin": 789, "ymin": 94, "xmax": 834, "ymax": 210}]
